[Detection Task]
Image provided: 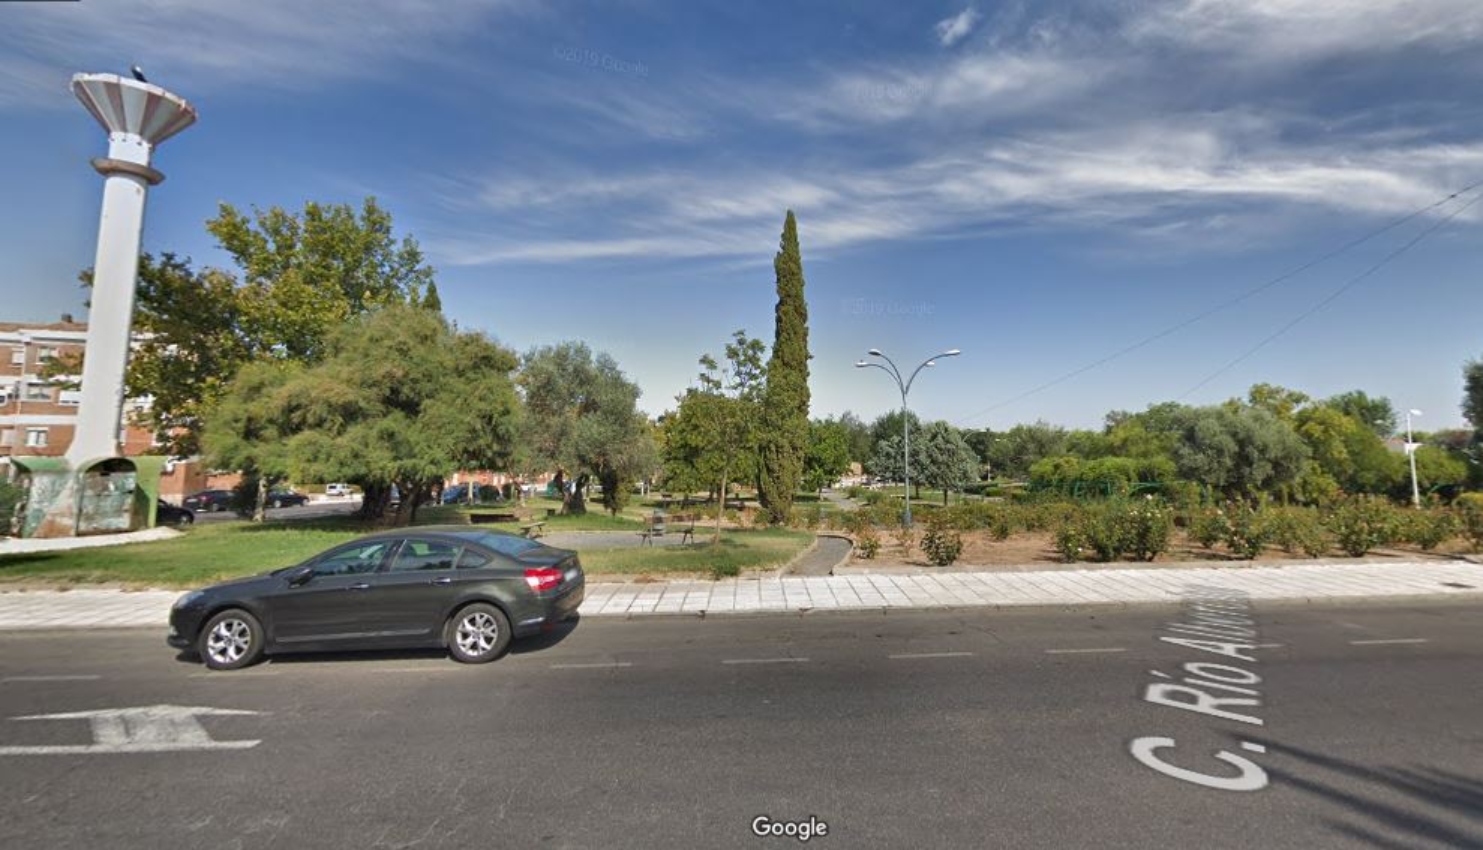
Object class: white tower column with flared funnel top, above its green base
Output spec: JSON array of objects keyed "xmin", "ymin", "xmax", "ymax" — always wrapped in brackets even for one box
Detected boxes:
[{"xmin": 67, "ymin": 74, "xmax": 196, "ymax": 466}]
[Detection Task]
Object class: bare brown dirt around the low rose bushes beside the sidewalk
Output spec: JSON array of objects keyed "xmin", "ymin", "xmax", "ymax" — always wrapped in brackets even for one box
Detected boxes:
[{"xmin": 850, "ymin": 531, "xmax": 1467, "ymax": 571}]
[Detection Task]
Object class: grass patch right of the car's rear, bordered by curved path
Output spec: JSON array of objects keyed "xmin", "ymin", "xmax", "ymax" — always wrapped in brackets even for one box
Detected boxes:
[{"xmin": 581, "ymin": 527, "xmax": 814, "ymax": 576}]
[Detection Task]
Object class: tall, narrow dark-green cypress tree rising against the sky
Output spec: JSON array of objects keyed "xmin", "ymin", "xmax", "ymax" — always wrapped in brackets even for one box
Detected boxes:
[{"xmin": 758, "ymin": 209, "xmax": 808, "ymax": 525}]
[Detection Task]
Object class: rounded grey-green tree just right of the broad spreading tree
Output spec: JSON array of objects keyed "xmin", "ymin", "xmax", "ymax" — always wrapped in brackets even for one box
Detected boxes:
[{"xmin": 519, "ymin": 343, "xmax": 655, "ymax": 515}]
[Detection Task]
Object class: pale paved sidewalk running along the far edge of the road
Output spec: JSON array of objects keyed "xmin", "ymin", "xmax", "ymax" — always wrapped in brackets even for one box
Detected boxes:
[{"xmin": 0, "ymin": 561, "xmax": 1483, "ymax": 630}]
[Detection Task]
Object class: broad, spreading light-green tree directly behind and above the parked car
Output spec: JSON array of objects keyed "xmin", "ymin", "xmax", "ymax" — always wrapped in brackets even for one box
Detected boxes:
[{"xmin": 205, "ymin": 306, "xmax": 519, "ymax": 524}]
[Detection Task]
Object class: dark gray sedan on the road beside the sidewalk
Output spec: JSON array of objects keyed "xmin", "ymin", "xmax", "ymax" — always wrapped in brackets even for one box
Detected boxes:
[{"xmin": 168, "ymin": 525, "xmax": 584, "ymax": 671}]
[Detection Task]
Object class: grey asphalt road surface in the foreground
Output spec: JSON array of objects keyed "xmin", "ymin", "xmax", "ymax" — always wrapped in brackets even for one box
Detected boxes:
[{"xmin": 0, "ymin": 604, "xmax": 1483, "ymax": 850}]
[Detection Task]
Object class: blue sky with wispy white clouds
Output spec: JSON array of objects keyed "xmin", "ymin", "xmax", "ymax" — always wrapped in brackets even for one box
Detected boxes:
[{"xmin": 0, "ymin": 0, "xmax": 1483, "ymax": 429}]
